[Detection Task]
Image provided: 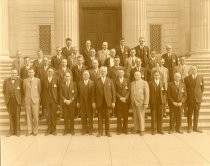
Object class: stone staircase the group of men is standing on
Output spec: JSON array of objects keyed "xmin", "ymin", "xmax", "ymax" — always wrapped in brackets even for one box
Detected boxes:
[{"xmin": 0, "ymin": 58, "xmax": 210, "ymax": 135}]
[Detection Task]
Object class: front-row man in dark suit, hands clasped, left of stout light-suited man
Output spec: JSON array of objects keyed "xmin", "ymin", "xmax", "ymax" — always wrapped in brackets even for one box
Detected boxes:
[{"xmin": 114, "ymin": 69, "xmax": 130, "ymax": 134}]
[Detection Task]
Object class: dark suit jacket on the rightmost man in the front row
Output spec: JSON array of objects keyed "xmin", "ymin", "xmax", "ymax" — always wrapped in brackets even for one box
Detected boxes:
[{"xmin": 184, "ymin": 75, "xmax": 204, "ymax": 104}]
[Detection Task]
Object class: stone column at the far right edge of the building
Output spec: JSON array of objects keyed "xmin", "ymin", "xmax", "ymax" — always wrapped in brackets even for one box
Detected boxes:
[{"xmin": 191, "ymin": 0, "xmax": 210, "ymax": 57}]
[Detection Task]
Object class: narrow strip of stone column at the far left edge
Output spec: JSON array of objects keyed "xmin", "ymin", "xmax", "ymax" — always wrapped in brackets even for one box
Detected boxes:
[{"xmin": 0, "ymin": 0, "xmax": 9, "ymax": 60}]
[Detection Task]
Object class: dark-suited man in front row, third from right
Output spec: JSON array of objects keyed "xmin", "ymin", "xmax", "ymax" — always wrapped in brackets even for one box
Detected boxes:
[{"xmin": 149, "ymin": 70, "xmax": 166, "ymax": 135}]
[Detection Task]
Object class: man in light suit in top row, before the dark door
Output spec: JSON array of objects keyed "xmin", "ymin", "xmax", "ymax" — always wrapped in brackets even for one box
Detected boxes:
[{"xmin": 98, "ymin": 42, "xmax": 110, "ymax": 66}]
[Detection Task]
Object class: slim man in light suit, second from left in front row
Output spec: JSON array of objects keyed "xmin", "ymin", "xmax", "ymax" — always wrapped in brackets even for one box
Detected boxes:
[{"xmin": 23, "ymin": 68, "xmax": 41, "ymax": 136}]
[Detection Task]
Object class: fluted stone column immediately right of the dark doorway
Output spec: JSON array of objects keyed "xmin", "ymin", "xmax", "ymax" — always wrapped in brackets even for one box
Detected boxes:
[{"xmin": 122, "ymin": 0, "xmax": 146, "ymax": 47}]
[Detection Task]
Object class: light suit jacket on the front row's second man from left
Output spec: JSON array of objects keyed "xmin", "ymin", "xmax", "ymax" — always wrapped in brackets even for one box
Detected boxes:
[{"xmin": 23, "ymin": 77, "xmax": 41, "ymax": 105}]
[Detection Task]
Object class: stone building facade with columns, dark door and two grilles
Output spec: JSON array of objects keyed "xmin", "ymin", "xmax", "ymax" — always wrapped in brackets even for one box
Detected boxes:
[{"xmin": 0, "ymin": 0, "xmax": 210, "ymax": 59}]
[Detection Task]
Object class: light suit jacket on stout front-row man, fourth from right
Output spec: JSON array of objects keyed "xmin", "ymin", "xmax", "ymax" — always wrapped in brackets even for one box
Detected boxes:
[{"xmin": 131, "ymin": 80, "xmax": 149, "ymax": 106}]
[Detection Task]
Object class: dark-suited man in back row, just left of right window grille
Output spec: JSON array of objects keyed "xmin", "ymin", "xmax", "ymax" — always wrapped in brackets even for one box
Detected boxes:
[{"xmin": 135, "ymin": 37, "xmax": 149, "ymax": 67}]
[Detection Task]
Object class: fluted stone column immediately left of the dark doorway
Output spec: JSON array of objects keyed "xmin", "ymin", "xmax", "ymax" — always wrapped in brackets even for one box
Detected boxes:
[{"xmin": 55, "ymin": 0, "xmax": 79, "ymax": 47}]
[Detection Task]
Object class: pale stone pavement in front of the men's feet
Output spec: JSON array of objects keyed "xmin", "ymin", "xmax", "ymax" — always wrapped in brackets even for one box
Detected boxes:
[{"xmin": 1, "ymin": 131, "xmax": 210, "ymax": 166}]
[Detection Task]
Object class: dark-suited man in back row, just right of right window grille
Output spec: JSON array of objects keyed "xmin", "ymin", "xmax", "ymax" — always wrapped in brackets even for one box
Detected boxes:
[{"xmin": 162, "ymin": 45, "xmax": 178, "ymax": 82}]
